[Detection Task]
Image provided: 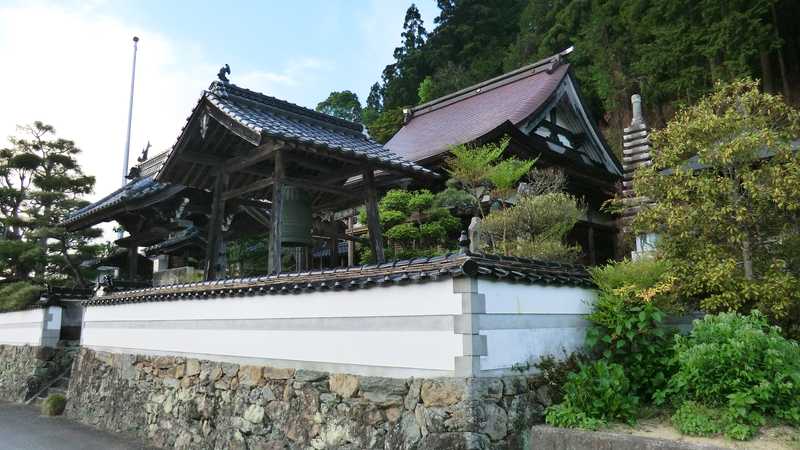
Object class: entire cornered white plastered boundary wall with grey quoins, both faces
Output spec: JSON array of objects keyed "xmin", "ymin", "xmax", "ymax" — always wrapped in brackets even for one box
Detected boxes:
[{"xmin": 81, "ymin": 277, "xmax": 594, "ymax": 378}]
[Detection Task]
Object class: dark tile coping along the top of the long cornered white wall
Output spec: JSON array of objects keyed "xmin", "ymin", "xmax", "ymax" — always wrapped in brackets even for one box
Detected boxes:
[{"xmin": 84, "ymin": 253, "xmax": 594, "ymax": 305}]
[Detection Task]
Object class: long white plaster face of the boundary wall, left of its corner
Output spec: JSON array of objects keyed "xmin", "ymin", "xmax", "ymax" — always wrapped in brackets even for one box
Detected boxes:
[{"xmin": 81, "ymin": 279, "xmax": 463, "ymax": 376}]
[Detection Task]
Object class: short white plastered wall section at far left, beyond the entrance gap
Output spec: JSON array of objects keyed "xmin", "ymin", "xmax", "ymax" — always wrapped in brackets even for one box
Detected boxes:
[{"xmin": 0, "ymin": 306, "xmax": 62, "ymax": 347}]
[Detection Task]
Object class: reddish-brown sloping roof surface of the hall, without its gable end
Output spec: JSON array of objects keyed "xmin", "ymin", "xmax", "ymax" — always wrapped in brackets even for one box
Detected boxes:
[{"xmin": 385, "ymin": 55, "xmax": 569, "ymax": 161}]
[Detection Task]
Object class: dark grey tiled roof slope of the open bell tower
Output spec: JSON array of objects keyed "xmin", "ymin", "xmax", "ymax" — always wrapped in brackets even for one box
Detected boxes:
[{"xmin": 204, "ymin": 81, "xmax": 432, "ymax": 174}]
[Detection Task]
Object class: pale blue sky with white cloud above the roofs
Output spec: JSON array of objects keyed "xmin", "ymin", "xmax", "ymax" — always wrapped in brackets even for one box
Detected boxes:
[{"xmin": 0, "ymin": 0, "xmax": 438, "ymax": 237}]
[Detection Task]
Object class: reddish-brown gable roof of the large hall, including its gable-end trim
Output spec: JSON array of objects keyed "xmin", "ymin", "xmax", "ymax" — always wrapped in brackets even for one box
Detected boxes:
[{"xmin": 386, "ymin": 51, "xmax": 622, "ymax": 176}]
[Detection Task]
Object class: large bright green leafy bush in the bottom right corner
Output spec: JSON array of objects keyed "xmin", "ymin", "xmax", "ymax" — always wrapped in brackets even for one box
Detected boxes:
[{"xmin": 663, "ymin": 311, "xmax": 800, "ymax": 439}]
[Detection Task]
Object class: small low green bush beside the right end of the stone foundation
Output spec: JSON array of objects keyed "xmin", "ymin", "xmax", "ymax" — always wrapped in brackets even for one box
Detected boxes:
[{"xmin": 545, "ymin": 360, "xmax": 639, "ymax": 430}]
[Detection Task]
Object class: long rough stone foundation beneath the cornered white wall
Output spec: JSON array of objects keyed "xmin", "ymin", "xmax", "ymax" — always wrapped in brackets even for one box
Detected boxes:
[{"xmin": 67, "ymin": 348, "xmax": 550, "ymax": 450}]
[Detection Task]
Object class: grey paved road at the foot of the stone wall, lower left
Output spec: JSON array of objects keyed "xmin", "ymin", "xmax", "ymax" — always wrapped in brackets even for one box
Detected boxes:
[{"xmin": 0, "ymin": 402, "xmax": 153, "ymax": 450}]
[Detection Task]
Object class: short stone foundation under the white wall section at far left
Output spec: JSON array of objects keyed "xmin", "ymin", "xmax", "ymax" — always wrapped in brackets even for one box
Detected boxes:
[{"xmin": 0, "ymin": 345, "xmax": 74, "ymax": 402}]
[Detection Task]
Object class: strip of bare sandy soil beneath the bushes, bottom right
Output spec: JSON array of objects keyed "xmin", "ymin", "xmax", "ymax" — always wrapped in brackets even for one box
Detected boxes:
[{"xmin": 609, "ymin": 417, "xmax": 800, "ymax": 450}]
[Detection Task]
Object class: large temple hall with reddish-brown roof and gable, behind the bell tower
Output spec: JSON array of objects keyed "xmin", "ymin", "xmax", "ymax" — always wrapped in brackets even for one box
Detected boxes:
[{"xmin": 386, "ymin": 52, "xmax": 622, "ymax": 264}]
